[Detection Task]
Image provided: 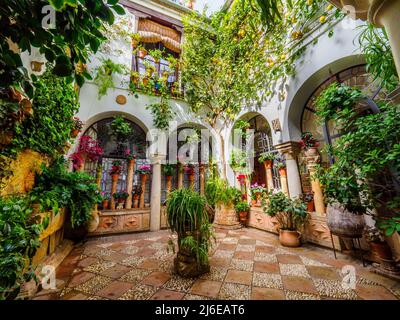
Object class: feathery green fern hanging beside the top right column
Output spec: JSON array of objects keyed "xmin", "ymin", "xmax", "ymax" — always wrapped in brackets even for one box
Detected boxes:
[{"xmin": 358, "ymin": 23, "xmax": 399, "ymax": 91}]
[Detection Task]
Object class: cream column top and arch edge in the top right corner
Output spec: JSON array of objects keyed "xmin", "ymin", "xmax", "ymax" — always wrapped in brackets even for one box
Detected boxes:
[{"xmin": 330, "ymin": 0, "xmax": 400, "ymax": 75}]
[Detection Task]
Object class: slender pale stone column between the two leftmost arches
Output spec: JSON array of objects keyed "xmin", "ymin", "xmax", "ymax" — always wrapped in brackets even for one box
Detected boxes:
[{"xmin": 150, "ymin": 155, "xmax": 165, "ymax": 231}]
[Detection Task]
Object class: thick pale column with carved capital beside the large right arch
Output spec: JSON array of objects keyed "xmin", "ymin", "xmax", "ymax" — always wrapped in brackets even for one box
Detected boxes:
[{"xmin": 275, "ymin": 141, "xmax": 302, "ymax": 198}]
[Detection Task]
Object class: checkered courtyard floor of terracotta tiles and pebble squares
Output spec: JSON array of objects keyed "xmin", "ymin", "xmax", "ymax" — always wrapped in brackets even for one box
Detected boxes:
[{"xmin": 34, "ymin": 228, "xmax": 400, "ymax": 300}]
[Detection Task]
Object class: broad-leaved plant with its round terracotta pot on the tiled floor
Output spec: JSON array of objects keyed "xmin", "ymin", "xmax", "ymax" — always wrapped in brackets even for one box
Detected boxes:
[{"xmin": 264, "ymin": 191, "xmax": 307, "ymax": 247}]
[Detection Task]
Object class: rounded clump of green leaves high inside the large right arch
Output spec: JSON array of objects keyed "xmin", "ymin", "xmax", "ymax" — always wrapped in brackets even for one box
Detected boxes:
[{"xmin": 316, "ymin": 82, "xmax": 363, "ymax": 122}]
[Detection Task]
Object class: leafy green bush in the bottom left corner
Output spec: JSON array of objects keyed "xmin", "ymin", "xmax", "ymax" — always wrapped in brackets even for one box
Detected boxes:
[{"xmin": 0, "ymin": 197, "xmax": 42, "ymax": 300}]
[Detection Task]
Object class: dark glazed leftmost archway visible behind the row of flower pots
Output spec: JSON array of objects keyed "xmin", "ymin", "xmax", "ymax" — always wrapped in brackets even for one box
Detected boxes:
[{"xmin": 83, "ymin": 117, "xmax": 151, "ymax": 203}]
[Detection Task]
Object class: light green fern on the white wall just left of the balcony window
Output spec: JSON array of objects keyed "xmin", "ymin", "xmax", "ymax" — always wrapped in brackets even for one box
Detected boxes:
[{"xmin": 94, "ymin": 58, "xmax": 128, "ymax": 99}]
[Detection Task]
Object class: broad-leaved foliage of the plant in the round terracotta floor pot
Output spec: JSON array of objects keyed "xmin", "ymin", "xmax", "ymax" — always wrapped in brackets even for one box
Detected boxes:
[{"xmin": 264, "ymin": 192, "xmax": 307, "ymax": 231}]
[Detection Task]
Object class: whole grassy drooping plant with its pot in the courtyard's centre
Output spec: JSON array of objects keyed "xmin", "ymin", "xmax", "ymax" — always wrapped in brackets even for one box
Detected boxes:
[{"xmin": 167, "ymin": 189, "xmax": 215, "ymax": 277}]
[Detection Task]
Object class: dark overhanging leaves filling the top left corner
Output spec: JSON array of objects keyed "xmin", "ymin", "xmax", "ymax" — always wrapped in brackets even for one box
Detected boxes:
[{"xmin": 0, "ymin": 0, "xmax": 124, "ymax": 97}]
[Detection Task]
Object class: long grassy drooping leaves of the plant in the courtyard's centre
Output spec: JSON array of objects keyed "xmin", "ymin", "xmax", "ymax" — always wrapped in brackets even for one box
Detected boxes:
[{"xmin": 167, "ymin": 188, "xmax": 214, "ymax": 267}]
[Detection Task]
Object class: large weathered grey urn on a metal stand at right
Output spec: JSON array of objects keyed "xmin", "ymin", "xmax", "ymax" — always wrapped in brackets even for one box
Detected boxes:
[{"xmin": 326, "ymin": 204, "xmax": 365, "ymax": 238}]
